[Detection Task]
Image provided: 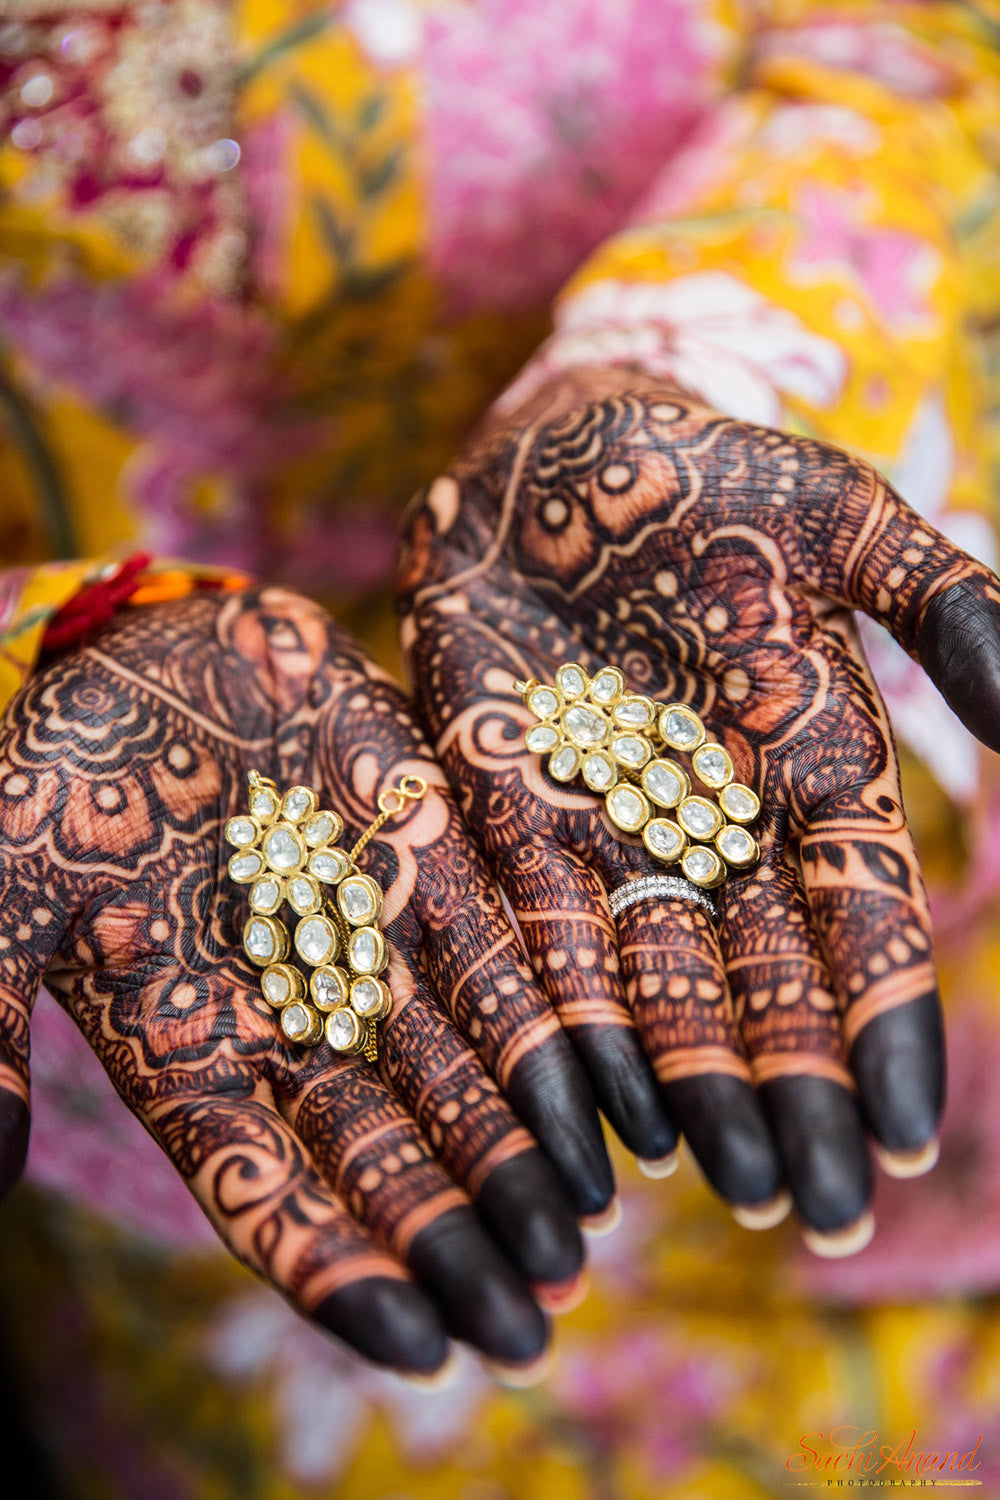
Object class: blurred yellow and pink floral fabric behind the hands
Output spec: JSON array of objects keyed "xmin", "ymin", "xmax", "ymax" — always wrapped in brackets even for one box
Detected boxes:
[{"xmin": 0, "ymin": 0, "xmax": 1000, "ymax": 1500}]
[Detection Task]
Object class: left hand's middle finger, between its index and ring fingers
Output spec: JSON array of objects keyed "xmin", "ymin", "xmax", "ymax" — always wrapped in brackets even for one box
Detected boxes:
[{"xmin": 279, "ymin": 1047, "xmax": 547, "ymax": 1365}]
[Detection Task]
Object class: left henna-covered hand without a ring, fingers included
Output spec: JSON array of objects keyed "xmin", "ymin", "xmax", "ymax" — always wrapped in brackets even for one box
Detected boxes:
[{"xmin": 0, "ymin": 590, "xmax": 612, "ymax": 1370}]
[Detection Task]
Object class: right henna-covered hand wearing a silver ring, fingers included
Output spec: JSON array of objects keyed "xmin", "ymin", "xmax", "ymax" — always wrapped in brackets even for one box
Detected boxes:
[{"xmin": 400, "ymin": 371, "xmax": 1000, "ymax": 1232}]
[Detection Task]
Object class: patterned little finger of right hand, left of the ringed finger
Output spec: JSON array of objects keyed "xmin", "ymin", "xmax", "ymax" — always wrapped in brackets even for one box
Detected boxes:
[{"xmin": 498, "ymin": 840, "xmax": 678, "ymax": 1160}]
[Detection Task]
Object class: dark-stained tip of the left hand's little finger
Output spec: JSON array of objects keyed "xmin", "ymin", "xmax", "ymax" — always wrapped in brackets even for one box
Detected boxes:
[{"xmin": 504, "ymin": 1032, "xmax": 615, "ymax": 1217}]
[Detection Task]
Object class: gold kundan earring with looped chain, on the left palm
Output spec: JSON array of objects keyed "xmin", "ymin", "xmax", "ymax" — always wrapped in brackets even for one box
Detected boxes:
[{"xmin": 225, "ymin": 771, "xmax": 427, "ymax": 1062}]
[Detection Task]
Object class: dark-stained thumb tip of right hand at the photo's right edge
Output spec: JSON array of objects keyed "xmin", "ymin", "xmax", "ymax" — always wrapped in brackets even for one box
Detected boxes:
[{"xmin": 918, "ymin": 581, "xmax": 1000, "ymax": 750}]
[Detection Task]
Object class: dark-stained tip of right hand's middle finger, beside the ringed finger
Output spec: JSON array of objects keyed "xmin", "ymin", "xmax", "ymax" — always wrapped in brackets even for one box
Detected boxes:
[{"xmin": 760, "ymin": 1074, "xmax": 873, "ymax": 1233}]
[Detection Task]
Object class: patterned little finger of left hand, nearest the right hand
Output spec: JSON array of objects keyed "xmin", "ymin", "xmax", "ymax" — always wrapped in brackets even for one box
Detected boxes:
[{"xmin": 423, "ymin": 849, "xmax": 615, "ymax": 1217}]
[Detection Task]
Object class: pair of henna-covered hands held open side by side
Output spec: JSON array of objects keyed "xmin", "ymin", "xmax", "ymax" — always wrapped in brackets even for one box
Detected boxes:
[{"xmin": 0, "ymin": 363, "xmax": 1000, "ymax": 1371}]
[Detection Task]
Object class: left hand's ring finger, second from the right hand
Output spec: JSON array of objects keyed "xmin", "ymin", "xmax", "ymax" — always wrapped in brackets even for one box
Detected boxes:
[{"xmin": 379, "ymin": 959, "xmax": 583, "ymax": 1287}]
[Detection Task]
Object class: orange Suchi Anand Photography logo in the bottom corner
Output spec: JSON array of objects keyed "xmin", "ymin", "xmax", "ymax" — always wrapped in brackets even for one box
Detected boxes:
[{"xmin": 784, "ymin": 1425, "xmax": 982, "ymax": 1490}]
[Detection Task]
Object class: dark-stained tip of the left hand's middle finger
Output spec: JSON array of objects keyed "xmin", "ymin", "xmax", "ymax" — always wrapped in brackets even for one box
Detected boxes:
[{"xmin": 408, "ymin": 1208, "xmax": 549, "ymax": 1365}]
